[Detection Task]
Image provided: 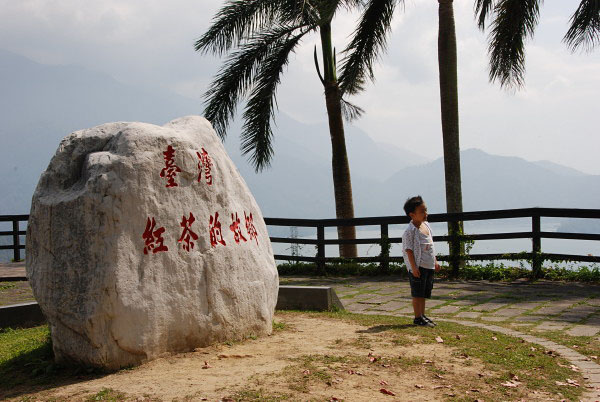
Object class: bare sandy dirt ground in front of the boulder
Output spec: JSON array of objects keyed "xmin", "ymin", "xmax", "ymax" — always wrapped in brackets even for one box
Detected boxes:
[{"xmin": 11, "ymin": 313, "xmax": 556, "ymax": 401}]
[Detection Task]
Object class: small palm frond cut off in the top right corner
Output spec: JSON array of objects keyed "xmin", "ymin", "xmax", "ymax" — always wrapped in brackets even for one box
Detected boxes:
[{"xmin": 563, "ymin": 0, "xmax": 600, "ymax": 52}]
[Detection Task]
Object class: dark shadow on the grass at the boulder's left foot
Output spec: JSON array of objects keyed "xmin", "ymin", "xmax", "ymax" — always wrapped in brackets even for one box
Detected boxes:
[{"xmin": 0, "ymin": 340, "xmax": 110, "ymax": 400}]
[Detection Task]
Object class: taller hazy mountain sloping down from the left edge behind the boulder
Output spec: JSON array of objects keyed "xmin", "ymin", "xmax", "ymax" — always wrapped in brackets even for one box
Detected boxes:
[{"xmin": 0, "ymin": 50, "xmax": 427, "ymax": 217}]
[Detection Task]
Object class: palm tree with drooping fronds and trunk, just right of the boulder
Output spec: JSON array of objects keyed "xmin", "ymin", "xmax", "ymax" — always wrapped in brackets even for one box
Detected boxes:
[{"xmin": 195, "ymin": 0, "xmax": 362, "ymax": 257}]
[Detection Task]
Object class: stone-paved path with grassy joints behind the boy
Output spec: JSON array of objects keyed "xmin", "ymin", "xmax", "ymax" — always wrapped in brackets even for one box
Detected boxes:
[{"xmin": 280, "ymin": 277, "xmax": 600, "ymax": 338}]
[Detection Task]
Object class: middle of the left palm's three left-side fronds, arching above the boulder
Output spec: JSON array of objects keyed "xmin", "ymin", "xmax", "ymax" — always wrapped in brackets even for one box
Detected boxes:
[{"xmin": 204, "ymin": 26, "xmax": 300, "ymax": 139}]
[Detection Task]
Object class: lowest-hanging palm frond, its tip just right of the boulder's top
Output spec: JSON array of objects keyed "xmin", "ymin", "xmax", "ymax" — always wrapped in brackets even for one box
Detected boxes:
[{"xmin": 241, "ymin": 29, "xmax": 309, "ymax": 172}]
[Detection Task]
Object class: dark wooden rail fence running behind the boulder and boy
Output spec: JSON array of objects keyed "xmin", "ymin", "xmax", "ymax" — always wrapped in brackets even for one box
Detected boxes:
[{"xmin": 0, "ymin": 208, "xmax": 600, "ymax": 276}]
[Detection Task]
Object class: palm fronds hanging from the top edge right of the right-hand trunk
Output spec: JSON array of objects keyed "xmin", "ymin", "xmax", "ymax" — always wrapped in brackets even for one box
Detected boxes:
[{"xmin": 475, "ymin": 0, "xmax": 600, "ymax": 87}]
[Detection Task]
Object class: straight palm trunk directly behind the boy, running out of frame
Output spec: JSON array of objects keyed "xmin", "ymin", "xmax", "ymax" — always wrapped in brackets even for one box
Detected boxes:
[{"xmin": 438, "ymin": 0, "xmax": 463, "ymax": 274}]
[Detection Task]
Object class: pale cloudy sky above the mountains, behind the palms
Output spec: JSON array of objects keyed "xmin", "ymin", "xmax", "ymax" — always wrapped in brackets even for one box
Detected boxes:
[{"xmin": 0, "ymin": 0, "xmax": 600, "ymax": 174}]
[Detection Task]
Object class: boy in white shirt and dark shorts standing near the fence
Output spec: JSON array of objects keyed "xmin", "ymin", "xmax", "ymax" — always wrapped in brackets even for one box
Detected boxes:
[{"xmin": 402, "ymin": 195, "xmax": 440, "ymax": 327}]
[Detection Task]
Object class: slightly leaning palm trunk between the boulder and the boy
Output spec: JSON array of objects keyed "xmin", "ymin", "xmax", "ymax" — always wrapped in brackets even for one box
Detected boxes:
[{"xmin": 320, "ymin": 24, "xmax": 358, "ymax": 258}]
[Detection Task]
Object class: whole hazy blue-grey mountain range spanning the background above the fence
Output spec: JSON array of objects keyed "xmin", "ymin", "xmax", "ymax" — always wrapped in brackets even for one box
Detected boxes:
[{"xmin": 0, "ymin": 51, "xmax": 600, "ymax": 225}]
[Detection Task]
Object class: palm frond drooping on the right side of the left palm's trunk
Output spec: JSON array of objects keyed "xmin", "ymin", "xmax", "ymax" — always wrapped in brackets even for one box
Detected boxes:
[{"xmin": 340, "ymin": 0, "xmax": 398, "ymax": 94}]
